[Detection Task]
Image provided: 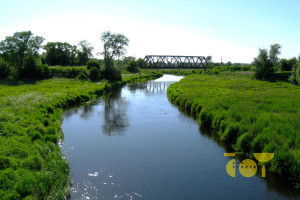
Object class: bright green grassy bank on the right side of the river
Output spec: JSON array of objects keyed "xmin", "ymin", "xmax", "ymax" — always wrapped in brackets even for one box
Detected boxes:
[{"xmin": 168, "ymin": 73, "xmax": 300, "ymax": 179}]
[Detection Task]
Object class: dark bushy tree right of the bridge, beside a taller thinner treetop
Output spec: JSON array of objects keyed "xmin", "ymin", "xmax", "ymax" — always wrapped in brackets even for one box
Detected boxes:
[{"xmin": 253, "ymin": 49, "xmax": 274, "ymax": 79}]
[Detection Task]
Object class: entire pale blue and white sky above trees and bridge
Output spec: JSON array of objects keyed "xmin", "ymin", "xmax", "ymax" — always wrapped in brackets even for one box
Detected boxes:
[{"xmin": 0, "ymin": 0, "xmax": 300, "ymax": 63}]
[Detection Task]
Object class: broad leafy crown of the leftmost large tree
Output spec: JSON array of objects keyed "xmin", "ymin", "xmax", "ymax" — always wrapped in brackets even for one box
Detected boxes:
[{"xmin": 0, "ymin": 31, "xmax": 45, "ymax": 70}]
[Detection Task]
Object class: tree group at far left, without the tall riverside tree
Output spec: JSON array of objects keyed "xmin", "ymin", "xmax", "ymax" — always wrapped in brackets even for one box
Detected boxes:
[{"xmin": 0, "ymin": 31, "xmax": 93, "ymax": 79}]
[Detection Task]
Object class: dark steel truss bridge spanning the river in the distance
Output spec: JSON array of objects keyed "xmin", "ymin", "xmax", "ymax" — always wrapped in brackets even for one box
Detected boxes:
[{"xmin": 143, "ymin": 55, "xmax": 210, "ymax": 69}]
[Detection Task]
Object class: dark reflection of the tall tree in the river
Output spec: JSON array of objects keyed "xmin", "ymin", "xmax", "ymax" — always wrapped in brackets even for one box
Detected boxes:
[{"xmin": 102, "ymin": 90, "xmax": 129, "ymax": 136}]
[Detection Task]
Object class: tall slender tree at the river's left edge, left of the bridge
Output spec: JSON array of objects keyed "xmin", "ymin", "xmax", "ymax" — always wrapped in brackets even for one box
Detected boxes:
[{"xmin": 101, "ymin": 31, "xmax": 129, "ymax": 81}]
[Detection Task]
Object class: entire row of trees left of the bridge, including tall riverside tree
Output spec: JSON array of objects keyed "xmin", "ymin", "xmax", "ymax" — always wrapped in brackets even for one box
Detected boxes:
[{"xmin": 0, "ymin": 31, "xmax": 135, "ymax": 81}]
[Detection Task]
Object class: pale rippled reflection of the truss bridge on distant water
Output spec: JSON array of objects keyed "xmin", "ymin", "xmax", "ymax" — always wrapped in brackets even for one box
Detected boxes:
[{"xmin": 128, "ymin": 81, "xmax": 175, "ymax": 95}]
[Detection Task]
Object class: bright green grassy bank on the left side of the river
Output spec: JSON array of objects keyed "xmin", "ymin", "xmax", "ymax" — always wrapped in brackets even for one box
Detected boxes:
[{"xmin": 0, "ymin": 73, "xmax": 162, "ymax": 199}]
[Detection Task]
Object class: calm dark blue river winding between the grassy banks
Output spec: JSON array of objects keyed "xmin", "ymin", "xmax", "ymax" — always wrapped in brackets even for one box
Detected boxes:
[{"xmin": 62, "ymin": 75, "xmax": 299, "ymax": 200}]
